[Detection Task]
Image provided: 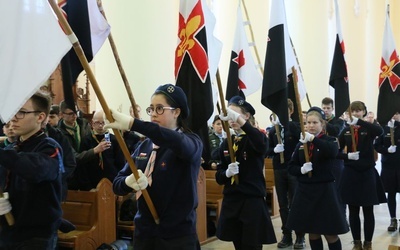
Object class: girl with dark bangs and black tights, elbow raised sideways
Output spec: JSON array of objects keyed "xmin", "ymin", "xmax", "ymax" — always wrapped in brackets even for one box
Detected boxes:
[{"xmin": 338, "ymin": 101, "xmax": 386, "ymax": 250}]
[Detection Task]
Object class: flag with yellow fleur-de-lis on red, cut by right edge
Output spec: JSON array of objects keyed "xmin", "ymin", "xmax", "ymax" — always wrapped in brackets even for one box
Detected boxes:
[{"xmin": 377, "ymin": 6, "xmax": 400, "ymax": 125}]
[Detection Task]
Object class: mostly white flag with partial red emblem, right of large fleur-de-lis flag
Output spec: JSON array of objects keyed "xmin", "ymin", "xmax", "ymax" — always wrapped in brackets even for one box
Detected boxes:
[{"xmin": 225, "ymin": 5, "xmax": 262, "ymax": 101}]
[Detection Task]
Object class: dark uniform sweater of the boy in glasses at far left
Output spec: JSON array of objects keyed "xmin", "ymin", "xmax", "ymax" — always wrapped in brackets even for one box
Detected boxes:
[{"xmin": 0, "ymin": 133, "xmax": 62, "ymax": 244}]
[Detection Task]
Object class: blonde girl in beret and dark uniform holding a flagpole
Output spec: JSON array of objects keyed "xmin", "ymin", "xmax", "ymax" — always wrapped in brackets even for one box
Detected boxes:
[{"xmin": 287, "ymin": 107, "xmax": 349, "ymax": 250}]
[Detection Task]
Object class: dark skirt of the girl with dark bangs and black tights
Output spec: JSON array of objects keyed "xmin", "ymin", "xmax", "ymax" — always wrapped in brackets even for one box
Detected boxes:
[{"xmin": 339, "ymin": 167, "xmax": 386, "ymax": 206}]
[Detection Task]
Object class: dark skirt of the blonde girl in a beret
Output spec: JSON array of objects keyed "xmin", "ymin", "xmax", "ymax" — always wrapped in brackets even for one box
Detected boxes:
[{"xmin": 287, "ymin": 182, "xmax": 349, "ymax": 235}]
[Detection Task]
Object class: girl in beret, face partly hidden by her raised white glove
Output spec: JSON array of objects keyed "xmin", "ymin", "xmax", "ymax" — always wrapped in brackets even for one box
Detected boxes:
[{"xmin": 215, "ymin": 96, "xmax": 276, "ymax": 250}]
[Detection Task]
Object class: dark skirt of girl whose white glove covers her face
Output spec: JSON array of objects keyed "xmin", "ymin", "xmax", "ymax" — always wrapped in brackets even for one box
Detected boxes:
[{"xmin": 216, "ymin": 197, "xmax": 276, "ymax": 246}]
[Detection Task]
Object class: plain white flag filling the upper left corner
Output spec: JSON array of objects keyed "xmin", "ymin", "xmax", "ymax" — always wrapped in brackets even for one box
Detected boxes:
[{"xmin": 0, "ymin": 0, "xmax": 71, "ymax": 122}]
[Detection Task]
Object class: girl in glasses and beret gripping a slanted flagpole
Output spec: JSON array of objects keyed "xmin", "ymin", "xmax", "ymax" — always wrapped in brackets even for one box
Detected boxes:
[{"xmin": 105, "ymin": 84, "xmax": 203, "ymax": 250}]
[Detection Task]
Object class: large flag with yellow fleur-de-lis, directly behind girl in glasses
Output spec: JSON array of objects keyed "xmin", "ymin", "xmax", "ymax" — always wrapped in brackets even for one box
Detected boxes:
[{"xmin": 175, "ymin": 0, "xmax": 221, "ymax": 162}]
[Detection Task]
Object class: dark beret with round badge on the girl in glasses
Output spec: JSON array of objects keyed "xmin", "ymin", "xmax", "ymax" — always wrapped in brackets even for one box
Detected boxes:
[{"xmin": 154, "ymin": 83, "xmax": 189, "ymax": 119}]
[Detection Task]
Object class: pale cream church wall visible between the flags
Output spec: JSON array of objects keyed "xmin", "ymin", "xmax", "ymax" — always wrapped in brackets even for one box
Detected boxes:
[{"xmin": 91, "ymin": 0, "xmax": 400, "ymax": 127}]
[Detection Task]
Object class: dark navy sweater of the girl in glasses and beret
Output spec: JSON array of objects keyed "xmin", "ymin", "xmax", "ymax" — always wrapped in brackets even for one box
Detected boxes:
[{"xmin": 113, "ymin": 119, "xmax": 203, "ymax": 239}]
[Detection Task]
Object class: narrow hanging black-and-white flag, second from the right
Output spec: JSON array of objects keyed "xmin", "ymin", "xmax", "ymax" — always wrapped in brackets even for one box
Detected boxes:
[{"xmin": 329, "ymin": 0, "xmax": 350, "ymax": 116}]
